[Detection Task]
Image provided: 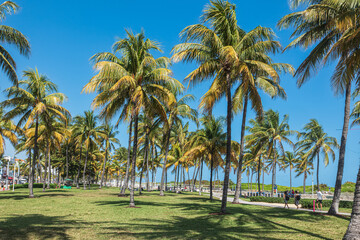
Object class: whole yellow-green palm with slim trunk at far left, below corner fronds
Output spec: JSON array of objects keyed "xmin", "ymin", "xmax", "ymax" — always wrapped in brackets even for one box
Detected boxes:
[{"xmin": 1, "ymin": 69, "xmax": 70, "ymax": 198}]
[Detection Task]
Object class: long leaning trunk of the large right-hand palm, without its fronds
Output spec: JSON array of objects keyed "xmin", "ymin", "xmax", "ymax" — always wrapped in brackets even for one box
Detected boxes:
[{"xmin": 328, "ymin": 82, "xmax": 351, "ymax": 215}]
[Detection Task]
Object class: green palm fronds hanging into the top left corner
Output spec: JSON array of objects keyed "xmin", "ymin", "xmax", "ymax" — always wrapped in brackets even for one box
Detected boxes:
[{"xmin": 0, "ymin": 1, "xmax": 30, "ymax": 86}]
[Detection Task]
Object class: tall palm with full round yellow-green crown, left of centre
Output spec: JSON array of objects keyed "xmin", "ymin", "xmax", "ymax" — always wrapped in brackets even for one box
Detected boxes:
[{"xmin": 83, "ymin": 31, "xmax": 182, "ymax": 207}]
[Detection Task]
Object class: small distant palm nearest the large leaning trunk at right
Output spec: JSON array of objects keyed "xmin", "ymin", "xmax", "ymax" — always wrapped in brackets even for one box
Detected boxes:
[{"xmin": 297, "ymin": 119, "xmax": 339, "ymax": 191}]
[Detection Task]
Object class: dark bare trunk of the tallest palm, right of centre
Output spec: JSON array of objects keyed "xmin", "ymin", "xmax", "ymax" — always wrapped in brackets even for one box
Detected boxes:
[{"xmin": 220, "ymin": 73, "xmax": 232, "ymax": 213}]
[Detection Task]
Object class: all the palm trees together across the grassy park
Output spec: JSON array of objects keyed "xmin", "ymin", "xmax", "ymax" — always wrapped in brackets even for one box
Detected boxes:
[{"xmin": 0, "ymin": 0, "xmax": 360, "ymax": 236}]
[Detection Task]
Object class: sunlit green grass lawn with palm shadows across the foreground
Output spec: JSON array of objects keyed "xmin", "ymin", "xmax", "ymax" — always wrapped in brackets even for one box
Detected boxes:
[{"xmin": 0, "ymin": 188, "xmax": 349, "ymax": 239}]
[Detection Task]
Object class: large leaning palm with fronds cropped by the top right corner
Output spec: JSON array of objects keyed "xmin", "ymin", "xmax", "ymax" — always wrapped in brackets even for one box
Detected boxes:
[{"xmin": 278, "ymin": 0, "xmax": 360, "ymax": 214}]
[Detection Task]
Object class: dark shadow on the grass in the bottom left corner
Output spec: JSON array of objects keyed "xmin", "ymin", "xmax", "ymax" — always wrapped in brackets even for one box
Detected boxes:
[{"xmin": 0, "ymin": 214, "xmax": 81, "ymax": 239}]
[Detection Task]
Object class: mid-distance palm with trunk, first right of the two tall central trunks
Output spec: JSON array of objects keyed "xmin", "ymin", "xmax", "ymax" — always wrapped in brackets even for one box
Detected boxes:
[{"xmin": 245, "ymin": 110, "xmax": 295, "ymax": 196}]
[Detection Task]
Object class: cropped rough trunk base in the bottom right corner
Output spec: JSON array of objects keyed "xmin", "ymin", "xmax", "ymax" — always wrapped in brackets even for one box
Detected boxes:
[{"xmin": 344, "ymin": 168, "xmax": 360, "ymax": 240}]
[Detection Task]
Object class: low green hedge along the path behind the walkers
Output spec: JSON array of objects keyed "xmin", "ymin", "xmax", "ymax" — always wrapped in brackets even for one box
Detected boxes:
[{"xmin": 250, "ymin": 197, "xmax": 353, "ymax": 209}]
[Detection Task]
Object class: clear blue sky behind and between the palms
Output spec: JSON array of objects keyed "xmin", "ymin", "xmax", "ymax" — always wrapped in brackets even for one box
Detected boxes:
[{"xmin": 0, "ymin": 0, "xmax": 360, "ymax": 186}]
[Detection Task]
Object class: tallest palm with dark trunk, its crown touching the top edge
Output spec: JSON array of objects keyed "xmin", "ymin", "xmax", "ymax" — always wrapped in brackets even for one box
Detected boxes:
[{"xmin": 173, "ymin": 0, "xmax": 278, "ymax": 213}]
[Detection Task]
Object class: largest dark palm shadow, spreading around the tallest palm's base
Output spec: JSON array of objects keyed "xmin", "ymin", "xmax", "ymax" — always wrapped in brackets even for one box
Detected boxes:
[{"xmin": 96, "ymin": 197, "xmax": 340, "ymax": 239}]
